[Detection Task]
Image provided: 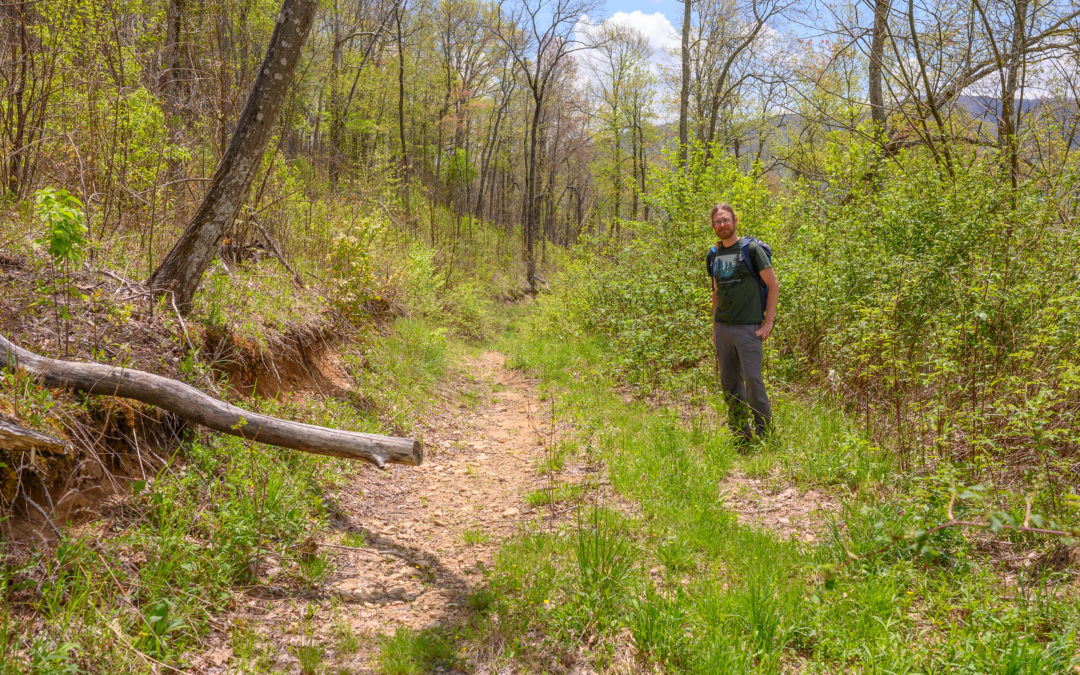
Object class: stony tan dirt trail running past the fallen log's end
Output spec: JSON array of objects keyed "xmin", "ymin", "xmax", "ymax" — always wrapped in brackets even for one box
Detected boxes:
[{"xmin": 193, "ymin": 352, "xmax": 551, "ymax": 673}]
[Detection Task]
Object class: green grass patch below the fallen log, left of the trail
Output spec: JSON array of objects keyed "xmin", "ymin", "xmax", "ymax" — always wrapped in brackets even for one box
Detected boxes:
[{"xmin": 0, "ymin": 425, "xmax": 337, "ymax": 673}]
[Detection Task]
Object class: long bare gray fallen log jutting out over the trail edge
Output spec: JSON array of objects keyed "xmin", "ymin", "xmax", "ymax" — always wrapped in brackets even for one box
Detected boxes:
[{"xmin": 0, "ymin": 335, "xmax": 423, "ymax": 468}]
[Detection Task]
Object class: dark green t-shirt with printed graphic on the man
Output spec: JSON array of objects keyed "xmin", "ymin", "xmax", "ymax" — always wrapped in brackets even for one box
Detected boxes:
[{"xmin": 705, "ymin": 242, "xmax": 772, "ymax": 324}]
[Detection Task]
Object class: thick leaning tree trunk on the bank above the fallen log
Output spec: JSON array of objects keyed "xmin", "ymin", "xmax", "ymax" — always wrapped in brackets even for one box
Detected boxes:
[{"xmin": 150, "ymin": 0, "xmax": 318, "ymax": 311}]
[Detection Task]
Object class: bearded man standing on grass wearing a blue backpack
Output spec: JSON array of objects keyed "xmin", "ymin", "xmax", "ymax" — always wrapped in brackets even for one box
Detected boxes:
[{"xmin": 705, "ymin": 203, "xmax": 780, "ymax": 442}]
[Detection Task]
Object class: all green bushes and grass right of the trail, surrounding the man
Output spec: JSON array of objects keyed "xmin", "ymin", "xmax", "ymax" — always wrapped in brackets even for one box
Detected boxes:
[{"xmin": 457, "ymin": 132, "xmax": 1080, "ymax": 673}]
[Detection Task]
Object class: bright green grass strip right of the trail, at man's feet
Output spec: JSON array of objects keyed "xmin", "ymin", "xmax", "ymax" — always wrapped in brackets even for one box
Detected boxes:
[{"xmin": 479, "ymin": 315, "xmax": 1080, "ymax": 673}]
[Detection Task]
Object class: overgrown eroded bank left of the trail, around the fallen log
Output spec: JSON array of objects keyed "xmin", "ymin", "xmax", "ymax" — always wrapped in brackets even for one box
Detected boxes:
[{"xmin": 0, "ymin": 194, "xmax": 521, "ymax": 674}]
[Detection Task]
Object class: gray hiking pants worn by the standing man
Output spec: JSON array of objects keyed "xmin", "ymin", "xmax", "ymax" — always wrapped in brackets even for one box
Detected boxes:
[{"xmin": 713, "ymin": 323, "xmax": 772, "ymax": 437}]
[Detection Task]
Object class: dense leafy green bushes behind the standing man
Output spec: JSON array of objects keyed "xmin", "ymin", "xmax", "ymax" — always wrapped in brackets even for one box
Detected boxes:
[{"xmin": 549, "ymin": 143, "xmax": 1080, "ymax": 479}]
